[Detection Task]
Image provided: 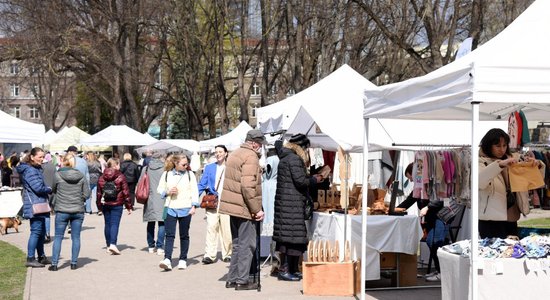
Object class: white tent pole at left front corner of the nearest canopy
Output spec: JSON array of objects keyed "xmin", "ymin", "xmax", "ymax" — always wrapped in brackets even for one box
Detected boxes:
[{"xmin": 361, "ymin": 118, "xmax": 369, "ymax": 300}]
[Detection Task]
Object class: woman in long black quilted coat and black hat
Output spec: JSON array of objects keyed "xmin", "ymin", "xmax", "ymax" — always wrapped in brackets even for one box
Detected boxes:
[{"xmin": 273, "ymin": 134, "xmax": 322, "ymax": 281}]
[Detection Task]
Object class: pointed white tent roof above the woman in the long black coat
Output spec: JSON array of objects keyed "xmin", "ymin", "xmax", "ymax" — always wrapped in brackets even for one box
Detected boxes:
[{"xmin": 285, "ymin": 65, "xmax": 375, "ymax": 152}]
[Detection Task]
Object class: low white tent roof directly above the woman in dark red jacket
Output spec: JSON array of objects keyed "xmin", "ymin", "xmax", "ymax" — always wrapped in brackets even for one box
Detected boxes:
[{"xmin": 81, "ymin": 125, "xmax": 157, "ymax": 146}]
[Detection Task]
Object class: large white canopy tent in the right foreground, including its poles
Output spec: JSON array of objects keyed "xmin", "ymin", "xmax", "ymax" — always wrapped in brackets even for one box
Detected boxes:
[{"xmin": 361, "ymin": 0, "xmax": 550, "ymax": 299}]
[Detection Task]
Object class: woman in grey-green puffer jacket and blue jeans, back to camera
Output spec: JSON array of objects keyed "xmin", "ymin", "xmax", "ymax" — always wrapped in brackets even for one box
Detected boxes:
[{"xmin": 48, "ymin": 154, "xmax": 90, "ymax": 271}]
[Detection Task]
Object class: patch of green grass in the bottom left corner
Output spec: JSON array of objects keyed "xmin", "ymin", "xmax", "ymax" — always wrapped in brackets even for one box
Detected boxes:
[{"xmin": 0, "ymin": 241, "xmax": 27, "ymax": 300}]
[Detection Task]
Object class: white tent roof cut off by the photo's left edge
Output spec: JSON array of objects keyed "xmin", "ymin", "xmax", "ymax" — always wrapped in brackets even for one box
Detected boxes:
[{"xmin": 0, "ymin": 110, "xmax": 46, "ymax": 144}]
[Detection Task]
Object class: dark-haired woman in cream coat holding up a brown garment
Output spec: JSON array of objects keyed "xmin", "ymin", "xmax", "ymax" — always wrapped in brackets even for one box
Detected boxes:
[{"xmin": 479, "ymin": 128, "xmax": 544, "ymax": 238}]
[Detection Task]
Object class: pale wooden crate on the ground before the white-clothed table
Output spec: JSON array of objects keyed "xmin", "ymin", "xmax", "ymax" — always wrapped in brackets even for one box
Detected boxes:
[{"xmin": 302, "ymin": 261, "xmax": 361, "ymax": 296}]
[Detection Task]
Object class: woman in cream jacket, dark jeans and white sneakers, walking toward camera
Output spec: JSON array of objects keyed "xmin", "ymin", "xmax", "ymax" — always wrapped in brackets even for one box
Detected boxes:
[{"xmin": 157, "ymin": 155, "xmax": 199, "ymax": 271}]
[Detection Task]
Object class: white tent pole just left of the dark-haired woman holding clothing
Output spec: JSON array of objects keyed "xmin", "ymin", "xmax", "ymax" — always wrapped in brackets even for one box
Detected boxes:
[{"xmin": 470, "ymin": 102, "xmax": 480, "ymax": 300}]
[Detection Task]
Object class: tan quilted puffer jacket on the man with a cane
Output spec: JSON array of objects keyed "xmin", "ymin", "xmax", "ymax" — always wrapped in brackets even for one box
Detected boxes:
[{"xmin": 219, "ymin": 144, "xmax": 262, "ymax": 220}]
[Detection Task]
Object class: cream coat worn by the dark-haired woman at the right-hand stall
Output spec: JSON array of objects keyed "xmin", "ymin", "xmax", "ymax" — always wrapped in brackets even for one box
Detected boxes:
[{"xmin": 479, "ymin": 150, "xmax": 544, "ymax": 222}]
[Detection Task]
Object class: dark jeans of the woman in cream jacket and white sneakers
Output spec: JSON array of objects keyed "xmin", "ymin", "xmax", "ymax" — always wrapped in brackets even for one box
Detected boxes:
[{"xmin": 164, "ymin": 215, "xmax": 191, "ymax": 260}]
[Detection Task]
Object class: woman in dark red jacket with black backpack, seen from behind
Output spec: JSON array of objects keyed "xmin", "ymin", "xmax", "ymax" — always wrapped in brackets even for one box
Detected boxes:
[{"xmin": 96, "ymin": 158, "xmax": 132, "ymax": 255}]
